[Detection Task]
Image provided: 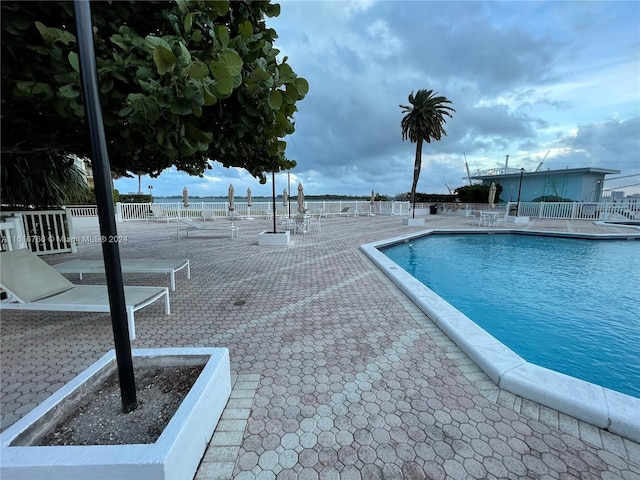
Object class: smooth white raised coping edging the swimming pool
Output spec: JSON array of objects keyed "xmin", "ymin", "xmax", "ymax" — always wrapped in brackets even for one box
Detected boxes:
[{"xmin": 360, "ymin": 228, "xmax": 640, "ymax": 442}]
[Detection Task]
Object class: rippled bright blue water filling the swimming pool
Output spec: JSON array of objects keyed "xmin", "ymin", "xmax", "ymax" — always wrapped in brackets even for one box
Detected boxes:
[{"xmin": 381, "ymin": 234, "xmax": 640, "ymax": 398}]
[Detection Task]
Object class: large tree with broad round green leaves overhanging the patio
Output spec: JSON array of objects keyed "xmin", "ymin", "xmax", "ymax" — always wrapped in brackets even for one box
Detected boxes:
[{"xmin": 1, "ymin": 0, "xmax": 309, "ymax": 202}]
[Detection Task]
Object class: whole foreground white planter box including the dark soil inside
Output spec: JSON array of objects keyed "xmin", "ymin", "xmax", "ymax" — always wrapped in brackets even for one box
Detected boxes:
[{"xmin": 0, "ymin": 348, "xmax": 231, "ymax": 480}]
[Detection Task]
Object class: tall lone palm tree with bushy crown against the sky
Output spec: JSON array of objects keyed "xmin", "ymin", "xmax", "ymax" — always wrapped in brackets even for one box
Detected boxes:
[{"xmin": 400, "ymin": 89, "xmax": 455, "ymax": 218}]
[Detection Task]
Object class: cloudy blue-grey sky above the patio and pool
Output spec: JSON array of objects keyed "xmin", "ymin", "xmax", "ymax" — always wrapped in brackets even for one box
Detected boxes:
[{"xmin": 116, "ymin": 1, "xmax": 640, "ymax": 196}]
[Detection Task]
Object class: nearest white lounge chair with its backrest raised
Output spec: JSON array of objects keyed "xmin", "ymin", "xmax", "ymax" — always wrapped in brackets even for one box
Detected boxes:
[{"xmin": 0, "ymin": 249, "xmax": 171, "ymax": 340}]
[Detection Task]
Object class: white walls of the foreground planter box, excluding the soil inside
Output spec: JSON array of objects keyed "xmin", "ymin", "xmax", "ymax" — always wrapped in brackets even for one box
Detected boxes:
[{"xmin": 0, "ymin": 348, "xmax": 231, "ymax": 480}]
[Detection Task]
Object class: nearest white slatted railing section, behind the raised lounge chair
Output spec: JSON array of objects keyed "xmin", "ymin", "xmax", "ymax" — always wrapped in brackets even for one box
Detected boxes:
[{"xmin": 0, "ymin": 209, "xmax": 77, "ymax": 255}]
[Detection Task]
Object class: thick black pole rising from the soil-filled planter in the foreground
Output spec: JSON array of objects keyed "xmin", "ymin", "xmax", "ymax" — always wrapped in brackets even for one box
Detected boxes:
[{"xmin": 74, "ymin": 0, "xmax": 138, "ymax": 413}]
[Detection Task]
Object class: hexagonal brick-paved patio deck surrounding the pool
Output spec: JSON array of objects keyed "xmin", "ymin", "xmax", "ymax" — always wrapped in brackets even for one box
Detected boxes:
[{"xmin": 0, "ymin": 215, "xmax": 640, "ymax": 480}]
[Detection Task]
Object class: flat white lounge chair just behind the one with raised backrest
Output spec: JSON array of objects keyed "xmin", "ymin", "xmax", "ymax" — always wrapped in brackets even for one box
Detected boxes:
[{"xmin": 52, "ymin": 259, "xmax": 191, "ymax": 292}]
